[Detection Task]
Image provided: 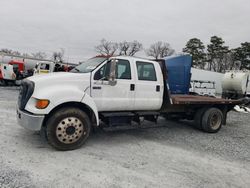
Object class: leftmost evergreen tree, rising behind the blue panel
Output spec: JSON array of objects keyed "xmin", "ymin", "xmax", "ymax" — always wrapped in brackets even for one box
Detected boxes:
[{"xmin": 183, "ymin": 38, "xmax": 206, "ymax": 69}]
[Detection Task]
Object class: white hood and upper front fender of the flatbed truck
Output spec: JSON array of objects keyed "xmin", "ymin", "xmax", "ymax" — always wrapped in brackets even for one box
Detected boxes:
[{"xmin": 25, "ymin": 72, "xmax": 91, "ymax": 114}]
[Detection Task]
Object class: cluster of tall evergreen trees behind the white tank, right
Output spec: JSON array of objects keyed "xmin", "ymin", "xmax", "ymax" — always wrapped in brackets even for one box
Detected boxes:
[{"xmin": 183, "ymin": 36, "xmax": 250, "ymax": 72}]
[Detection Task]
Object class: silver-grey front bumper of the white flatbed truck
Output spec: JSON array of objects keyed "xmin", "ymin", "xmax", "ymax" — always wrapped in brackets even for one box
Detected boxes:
[{"xmin": 17, "ymin": 109, "xmax": 45, "ymax": 131}]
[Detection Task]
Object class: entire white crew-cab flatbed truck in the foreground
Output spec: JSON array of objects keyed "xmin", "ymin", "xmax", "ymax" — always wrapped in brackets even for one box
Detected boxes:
[{"xmin": 17, "ymin": 56, "xmax": 246, "ymax": 150}]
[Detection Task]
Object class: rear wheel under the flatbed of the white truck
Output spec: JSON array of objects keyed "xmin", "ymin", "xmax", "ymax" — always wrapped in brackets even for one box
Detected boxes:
[{"xmin": 201, "ymin": 108, "xmax": 223, "ymax": 133}]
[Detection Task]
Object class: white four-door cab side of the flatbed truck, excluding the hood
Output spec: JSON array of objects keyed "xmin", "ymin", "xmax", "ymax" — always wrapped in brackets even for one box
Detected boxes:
[{"xmin": 88, "ymin": 57, "xmax": 163, "ymax": 112}]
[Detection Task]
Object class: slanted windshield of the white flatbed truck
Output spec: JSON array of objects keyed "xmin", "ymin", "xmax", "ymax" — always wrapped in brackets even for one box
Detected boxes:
[{"xmin": 70, "ymin": 57, "xmax": 107, "ymax": 73}]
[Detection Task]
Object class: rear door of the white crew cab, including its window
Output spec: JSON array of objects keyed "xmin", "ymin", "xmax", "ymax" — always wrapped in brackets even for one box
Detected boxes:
[{"xmin": 134, "ymin": 61, "xmax": 164, "ymax": 111}]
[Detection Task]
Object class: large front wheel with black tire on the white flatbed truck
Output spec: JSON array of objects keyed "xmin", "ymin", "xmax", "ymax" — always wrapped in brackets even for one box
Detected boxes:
[{"xmin": 46, "ymin": 107, "xmax": 91, "ymax": 151}]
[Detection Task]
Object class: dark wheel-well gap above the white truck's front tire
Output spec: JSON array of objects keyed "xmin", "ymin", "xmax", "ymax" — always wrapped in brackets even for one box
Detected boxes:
[{"xmin": 43, "ymin": 102, "xmax": 97, "ymax": 127}]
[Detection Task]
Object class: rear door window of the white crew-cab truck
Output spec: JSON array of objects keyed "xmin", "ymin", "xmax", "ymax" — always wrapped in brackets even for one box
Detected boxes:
[{"xmin": 136, "ymin": 61, "xmax": 157, "ymax": 81}]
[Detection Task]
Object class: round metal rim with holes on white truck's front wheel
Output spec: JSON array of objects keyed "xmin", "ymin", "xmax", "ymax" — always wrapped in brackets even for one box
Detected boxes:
[{"xmin": 56, "ymin": 117, "xmax": 87, "ymax": 144}]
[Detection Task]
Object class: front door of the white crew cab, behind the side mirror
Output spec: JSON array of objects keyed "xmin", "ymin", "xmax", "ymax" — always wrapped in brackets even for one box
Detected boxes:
[{"xmin": 91, "ymin": 59, "xmax": 135, "ymax": 112}]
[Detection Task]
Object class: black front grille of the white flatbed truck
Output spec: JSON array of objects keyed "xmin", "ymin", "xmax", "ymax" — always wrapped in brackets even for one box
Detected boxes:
[{"xmin": 18, "ymin": 80, "xmax": 35, "ymax": 110}]
